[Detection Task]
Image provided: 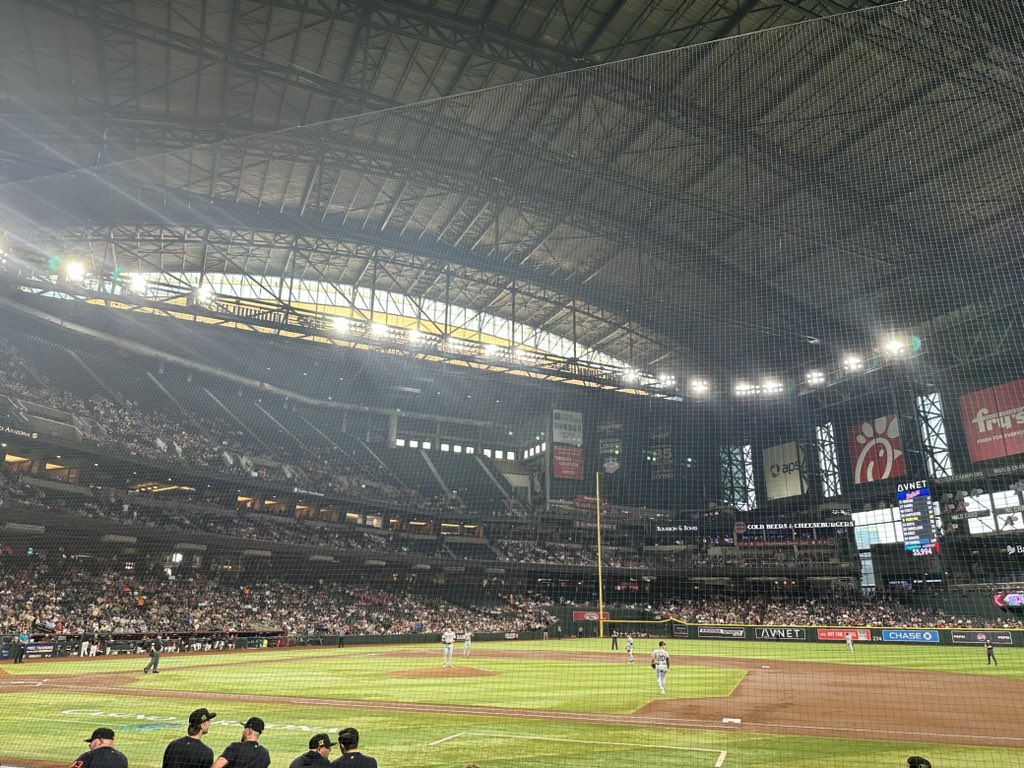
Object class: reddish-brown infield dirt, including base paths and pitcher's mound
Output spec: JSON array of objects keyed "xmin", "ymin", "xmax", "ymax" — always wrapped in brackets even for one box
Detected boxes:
[{"xmin": 0, "ymin": 647, "xmax": 1024, "ymax": 749}]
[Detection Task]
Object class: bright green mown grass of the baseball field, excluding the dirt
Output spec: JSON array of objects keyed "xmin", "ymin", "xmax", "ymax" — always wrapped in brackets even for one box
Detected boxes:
[{"xmin": 0, "ymin": 640, "xmax": 1024, "ymax": 768}]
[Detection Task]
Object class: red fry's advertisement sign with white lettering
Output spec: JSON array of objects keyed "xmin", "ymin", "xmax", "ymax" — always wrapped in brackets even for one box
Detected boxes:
[{"xmin": 961, "ymin": 379, "xmax": 1024, "ymax": 462}]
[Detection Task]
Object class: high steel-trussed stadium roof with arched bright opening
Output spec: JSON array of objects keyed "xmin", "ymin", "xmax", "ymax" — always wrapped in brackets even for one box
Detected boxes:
[{"xmin": 0, "ymin": 0, "xmax": 1022, "ymax": 393}]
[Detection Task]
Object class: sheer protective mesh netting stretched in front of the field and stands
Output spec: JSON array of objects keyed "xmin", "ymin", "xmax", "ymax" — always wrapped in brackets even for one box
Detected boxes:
[{"xmin": 0, "ymin": 2, "xmax": 1024, "ymax": 768}]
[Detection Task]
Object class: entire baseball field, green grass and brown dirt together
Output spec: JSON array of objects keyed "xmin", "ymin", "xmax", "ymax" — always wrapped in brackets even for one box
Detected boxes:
[{"xmin": 0, "ymin": 640, "xmax": 1024, "ymax": 768}]
